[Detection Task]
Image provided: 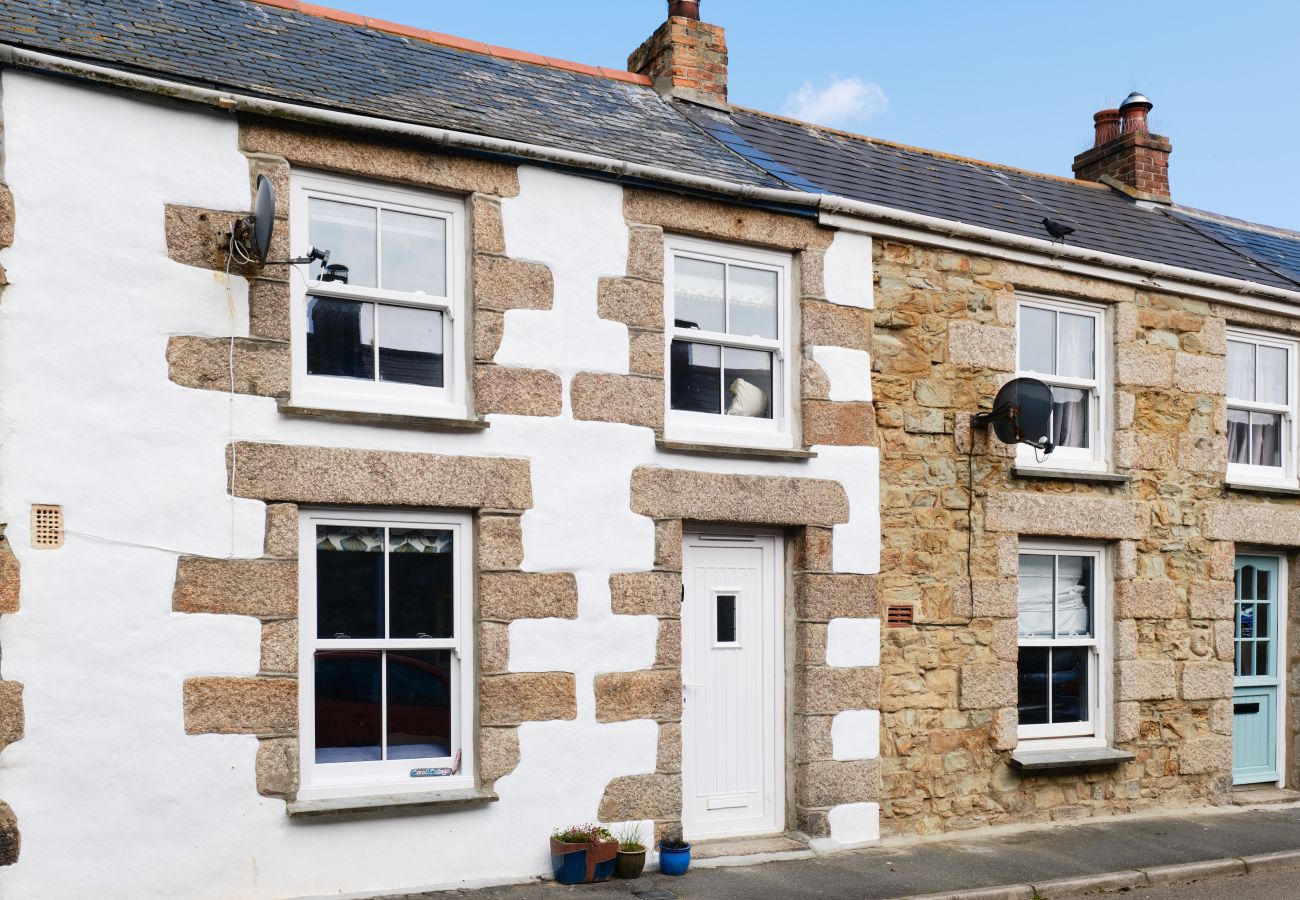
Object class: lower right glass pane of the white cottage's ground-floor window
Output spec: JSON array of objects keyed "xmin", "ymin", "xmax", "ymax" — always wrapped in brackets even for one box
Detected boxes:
[{"xmin": 386, "ymin": 650, "xmax": 452, "ymax": 760}]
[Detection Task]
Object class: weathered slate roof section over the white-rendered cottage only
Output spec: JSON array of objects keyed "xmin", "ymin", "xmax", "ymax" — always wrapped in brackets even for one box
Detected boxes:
[{"xmin": 0, "ymin": 0, "xmax": 781, "ymax": 187}]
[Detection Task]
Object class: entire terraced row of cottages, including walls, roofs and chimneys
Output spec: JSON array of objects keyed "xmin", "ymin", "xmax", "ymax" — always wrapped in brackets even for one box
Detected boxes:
[{"xmin": 0, "ymin": 0, "xmax": 1300, "ymax": 899}]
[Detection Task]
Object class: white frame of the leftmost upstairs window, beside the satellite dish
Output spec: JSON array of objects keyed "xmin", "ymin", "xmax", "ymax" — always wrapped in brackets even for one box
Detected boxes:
[{"xmin": 289, "ymin": 170, "xmax": 469, "ymax": 419}]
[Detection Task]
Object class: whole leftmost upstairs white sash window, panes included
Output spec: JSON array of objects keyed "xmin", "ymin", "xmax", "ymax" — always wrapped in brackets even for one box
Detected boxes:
[{"xmin": 289, "ymin": 173, "xmax": 467, "ymax": 417}]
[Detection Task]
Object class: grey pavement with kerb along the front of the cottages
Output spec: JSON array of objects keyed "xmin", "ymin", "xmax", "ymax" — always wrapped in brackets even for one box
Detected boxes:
[{"xmin": 371, "ymin": 805, "xmax": 1300, "ymax": 900}]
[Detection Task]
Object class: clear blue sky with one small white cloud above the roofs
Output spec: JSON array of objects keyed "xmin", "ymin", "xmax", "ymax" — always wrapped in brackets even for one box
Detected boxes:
[{"xmin": 338, "ymin": 0, "xmax": 1300, "ymax": 229}]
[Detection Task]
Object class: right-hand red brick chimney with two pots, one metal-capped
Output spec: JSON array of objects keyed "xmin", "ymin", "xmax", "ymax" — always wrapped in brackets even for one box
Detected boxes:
[{"xmin": 1074, "ymin": 91, "xmax": 1174, "ymax": 203}]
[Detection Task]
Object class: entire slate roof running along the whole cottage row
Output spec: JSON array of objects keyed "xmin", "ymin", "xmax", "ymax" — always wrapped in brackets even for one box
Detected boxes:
[{"xmin": 0, "ymin": 0, "xmax": 1300, "ymax": 290}]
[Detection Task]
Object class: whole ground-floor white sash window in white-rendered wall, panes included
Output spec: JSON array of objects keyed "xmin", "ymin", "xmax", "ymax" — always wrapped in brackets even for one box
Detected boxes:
[{"xmin": 298, "ymin": 510, "xmax": 475, "ymax": 800}]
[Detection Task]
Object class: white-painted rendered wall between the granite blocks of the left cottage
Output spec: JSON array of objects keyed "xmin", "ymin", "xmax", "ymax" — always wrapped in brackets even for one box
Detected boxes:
[{"xmin": 0, "ymin": 72, "xmax": 880, "ymax": 900}]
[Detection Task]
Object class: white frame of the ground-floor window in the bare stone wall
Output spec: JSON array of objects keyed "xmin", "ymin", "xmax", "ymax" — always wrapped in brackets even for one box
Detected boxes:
[{"xmin": 1015, "ymin": 540, "xmax": 1113, "ymax": 750}]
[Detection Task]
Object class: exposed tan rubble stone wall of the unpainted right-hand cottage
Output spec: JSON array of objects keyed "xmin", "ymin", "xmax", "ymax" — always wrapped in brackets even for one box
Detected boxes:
[{"xmin": 872, "ymin": 242, "xmax": 1300, "ymax": 835}]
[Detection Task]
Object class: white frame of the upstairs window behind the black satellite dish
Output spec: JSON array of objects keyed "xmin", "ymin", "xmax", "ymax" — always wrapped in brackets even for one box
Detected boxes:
[{"xmin": 1015, "ymin": 294, "xmax": 1113, "ymax": 472}]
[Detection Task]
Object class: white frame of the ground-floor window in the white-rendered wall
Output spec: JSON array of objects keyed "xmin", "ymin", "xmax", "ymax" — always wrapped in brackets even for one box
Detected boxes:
[{"xmin": 298, "ymin": 509, "xmax": 477, "ymax": 800}]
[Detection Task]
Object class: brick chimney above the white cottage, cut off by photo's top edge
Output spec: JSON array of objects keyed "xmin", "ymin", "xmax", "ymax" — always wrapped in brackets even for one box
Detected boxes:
[{"xmin": 628, "ymin": 0, "xmax": 728, "ymax": 109}]
